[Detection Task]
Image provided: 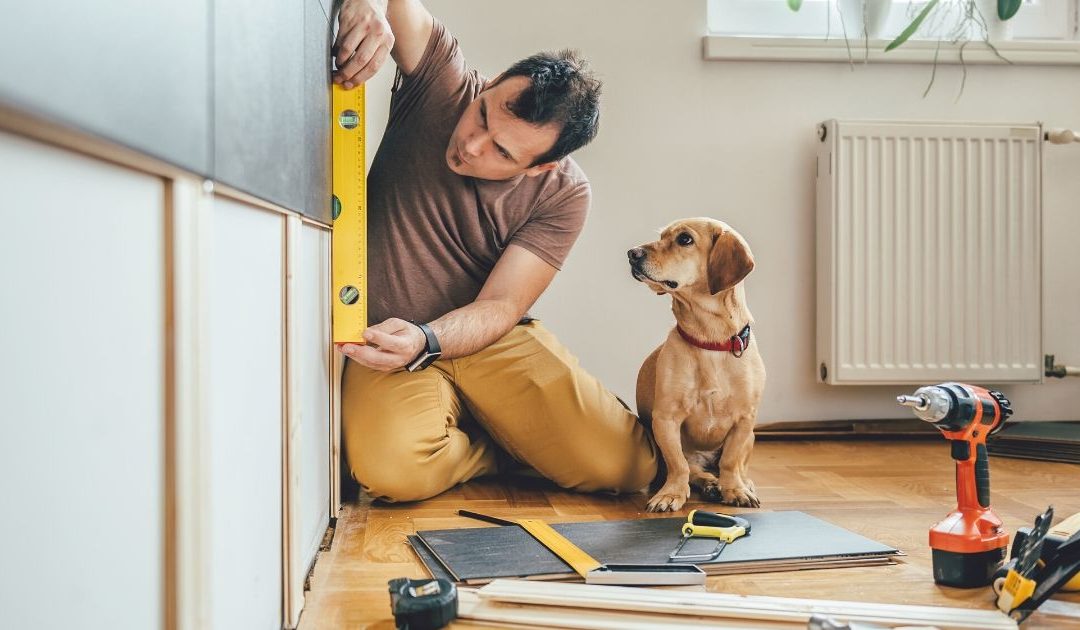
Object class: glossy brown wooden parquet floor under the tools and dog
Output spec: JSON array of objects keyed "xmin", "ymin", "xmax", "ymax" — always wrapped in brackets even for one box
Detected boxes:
[{"xmin": 300, "ymin": 440, "xmax": 1080, "ymax": 630}]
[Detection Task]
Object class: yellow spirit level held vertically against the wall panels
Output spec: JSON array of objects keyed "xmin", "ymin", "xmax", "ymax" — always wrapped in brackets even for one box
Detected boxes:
[{"xmin": 330, "ymin": 84, "xmax": 367, "ymax": 344}]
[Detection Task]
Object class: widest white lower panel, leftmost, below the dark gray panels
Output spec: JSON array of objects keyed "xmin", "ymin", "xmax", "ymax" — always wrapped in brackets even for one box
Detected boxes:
[{"xmin": 0, "ymin": 133, "xmax": 165, "ymax": 630}]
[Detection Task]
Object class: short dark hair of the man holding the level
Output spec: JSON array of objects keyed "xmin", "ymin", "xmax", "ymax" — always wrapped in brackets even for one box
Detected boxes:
[{"xmin": 499, "ymin": 50, "xmax": 600, "ymax": 166}]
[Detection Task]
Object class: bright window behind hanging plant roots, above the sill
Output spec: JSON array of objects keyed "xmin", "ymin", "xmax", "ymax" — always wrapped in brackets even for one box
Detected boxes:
[{"xmin": 707, "ymin": 0, "xmax": 1078, "ymax": 40}]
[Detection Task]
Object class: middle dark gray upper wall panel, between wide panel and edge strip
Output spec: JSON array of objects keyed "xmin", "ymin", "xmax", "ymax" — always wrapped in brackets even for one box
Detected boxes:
[{"xmin": 214, "ymin": 0, "xmax": 308, "ymax": 210}]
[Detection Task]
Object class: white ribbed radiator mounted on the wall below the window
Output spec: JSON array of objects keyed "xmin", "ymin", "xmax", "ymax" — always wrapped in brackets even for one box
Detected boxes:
[{"xmin": 816, "ymin": 120, "xmax": 1042, "ymax": 385}]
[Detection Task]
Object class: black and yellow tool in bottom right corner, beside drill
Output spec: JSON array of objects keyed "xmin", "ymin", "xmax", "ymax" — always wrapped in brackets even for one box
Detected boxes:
[{"xmin": 994, "ymin": 506, "xmax": 1080, "ymax": 621}]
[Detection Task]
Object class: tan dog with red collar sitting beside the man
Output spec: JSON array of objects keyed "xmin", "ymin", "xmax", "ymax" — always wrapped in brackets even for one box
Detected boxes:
[{"xmin": 627, "ymin": 218, "xmax": 765, "ymax": 512}]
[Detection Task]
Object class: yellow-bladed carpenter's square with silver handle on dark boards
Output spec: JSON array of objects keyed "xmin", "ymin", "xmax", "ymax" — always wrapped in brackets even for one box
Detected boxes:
[{"xmin": 458, "ymin": 510, "xmax": 705, "ymax": 586}]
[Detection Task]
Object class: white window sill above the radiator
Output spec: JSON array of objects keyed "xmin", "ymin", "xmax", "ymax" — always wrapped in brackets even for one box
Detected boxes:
[{"xmin": 702, "ymin": 35, "xmax": 1080, "ymax": 66}]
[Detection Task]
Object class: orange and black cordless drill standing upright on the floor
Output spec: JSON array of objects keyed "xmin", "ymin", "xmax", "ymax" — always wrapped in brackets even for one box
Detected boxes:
[{"xmin": 896, "ymin": 383, "xmax": 1012, "ymax": 588}]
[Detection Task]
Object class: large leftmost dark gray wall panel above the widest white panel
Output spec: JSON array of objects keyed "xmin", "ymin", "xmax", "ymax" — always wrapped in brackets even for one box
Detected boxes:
[{"xmin": 0, "ymin": 0, "xmax": 211, "ymax": 174}]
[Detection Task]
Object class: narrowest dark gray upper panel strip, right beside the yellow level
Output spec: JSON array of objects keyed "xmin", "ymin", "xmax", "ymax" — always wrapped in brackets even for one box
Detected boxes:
[{"xmin": 302, "ymin": 0, "xmax": 332, "ymax": 223}]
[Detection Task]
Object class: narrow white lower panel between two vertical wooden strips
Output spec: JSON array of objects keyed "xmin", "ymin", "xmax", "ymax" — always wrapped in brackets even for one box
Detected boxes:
[{"xmin": 206, "ymin": 197, "xmax": 284, "ymax": 630}]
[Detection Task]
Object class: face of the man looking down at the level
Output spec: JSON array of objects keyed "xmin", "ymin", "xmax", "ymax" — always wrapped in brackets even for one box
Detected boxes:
[{"xmin": 446, "ymin": 77, "xmax": 559, "ymax": 179}]
